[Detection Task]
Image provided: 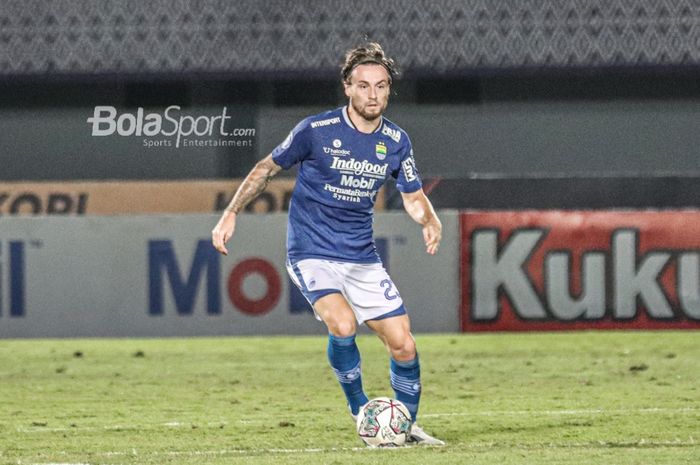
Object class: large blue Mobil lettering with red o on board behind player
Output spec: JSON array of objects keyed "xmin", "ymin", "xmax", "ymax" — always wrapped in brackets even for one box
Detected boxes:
[{"xmin": 148, "ymin": 238, "xmax": 389, "ymax": 316}]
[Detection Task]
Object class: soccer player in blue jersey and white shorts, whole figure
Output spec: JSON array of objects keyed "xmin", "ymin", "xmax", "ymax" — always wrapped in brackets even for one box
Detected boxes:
[{"xmin": 212, "ymin": 43, "xmax": 444, "ymax": 445}]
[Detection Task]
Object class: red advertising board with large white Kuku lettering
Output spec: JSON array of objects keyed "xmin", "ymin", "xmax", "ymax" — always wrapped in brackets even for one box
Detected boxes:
[{"xmin": 460, "ymin": 210, "xmax": 700, "ymax": 331}]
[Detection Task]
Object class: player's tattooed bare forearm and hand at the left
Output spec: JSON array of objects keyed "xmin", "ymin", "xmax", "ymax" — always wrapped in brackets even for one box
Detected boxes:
[{"xmin": 211, "ymin": 154, "xmax": 282, "ymax": 255}]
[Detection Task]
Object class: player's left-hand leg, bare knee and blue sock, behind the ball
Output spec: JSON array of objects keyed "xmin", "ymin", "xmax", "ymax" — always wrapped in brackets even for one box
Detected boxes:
[{"xmin": 314, "ymin": 293, "xmax": 367, "ymax": 416}]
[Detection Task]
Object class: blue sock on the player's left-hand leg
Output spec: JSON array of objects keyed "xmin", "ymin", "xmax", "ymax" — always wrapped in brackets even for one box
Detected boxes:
[{"xmin": 328, "ymin": 334, "xmax": 368, "ymax": 415}]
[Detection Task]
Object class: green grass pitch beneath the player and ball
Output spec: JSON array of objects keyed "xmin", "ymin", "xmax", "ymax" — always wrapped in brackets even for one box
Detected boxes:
[{"xmin": 0, "ymin": 331, "xmax": 700, "ymax": 465}]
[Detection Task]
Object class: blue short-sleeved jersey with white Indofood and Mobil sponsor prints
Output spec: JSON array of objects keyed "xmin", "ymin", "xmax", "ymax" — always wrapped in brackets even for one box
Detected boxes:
[{"xmin": 272, "ymin": 107, "xmax": 421, "ymax": 263}]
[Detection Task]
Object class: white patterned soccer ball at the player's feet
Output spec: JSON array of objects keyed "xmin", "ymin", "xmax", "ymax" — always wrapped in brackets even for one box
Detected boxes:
[{"xmin": 357, "ymin": 397, "xmax": 411, "ymax": 447}]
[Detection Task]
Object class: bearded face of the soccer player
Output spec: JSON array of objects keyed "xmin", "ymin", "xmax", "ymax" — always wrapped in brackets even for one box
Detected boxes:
[{"xmin": 344, "ymin": 63, "xmax": 390, "ymax": 121}]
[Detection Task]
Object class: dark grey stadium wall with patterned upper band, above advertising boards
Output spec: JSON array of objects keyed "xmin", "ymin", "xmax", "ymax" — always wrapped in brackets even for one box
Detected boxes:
[{"xmin": 0, "ymin": 0, "xmax": 700, "ymax": 208}]
